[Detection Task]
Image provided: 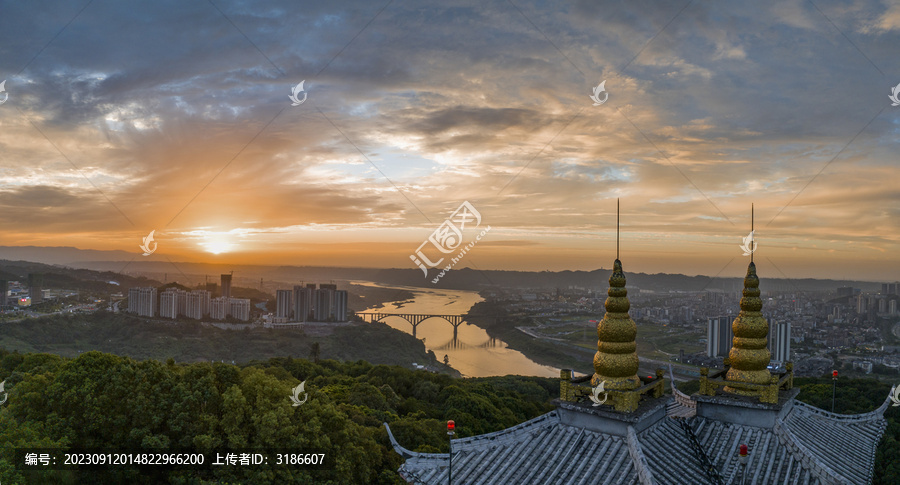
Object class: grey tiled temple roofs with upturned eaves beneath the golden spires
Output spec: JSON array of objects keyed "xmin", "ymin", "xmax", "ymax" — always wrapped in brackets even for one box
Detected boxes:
[{"xmin": 385, "ymin": 399, "xmax": 888, "ymax": 485}]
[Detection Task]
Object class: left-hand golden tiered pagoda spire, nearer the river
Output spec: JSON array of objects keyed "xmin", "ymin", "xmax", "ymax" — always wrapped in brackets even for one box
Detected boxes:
[{"xmin": 591, "ymin": 200, "xmax": 641, "ymax": 391}]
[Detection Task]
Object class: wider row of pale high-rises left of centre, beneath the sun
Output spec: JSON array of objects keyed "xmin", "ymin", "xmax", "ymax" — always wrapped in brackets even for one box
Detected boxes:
[{"xmin": 128, "ymin": 274, "xmax": 250, "ymax": 322}]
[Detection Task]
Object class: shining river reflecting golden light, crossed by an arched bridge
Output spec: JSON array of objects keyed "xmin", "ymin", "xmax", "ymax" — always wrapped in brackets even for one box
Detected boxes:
[{"xmin": 351, "ymin": 281, "xmax": 559, "ymax": 377}]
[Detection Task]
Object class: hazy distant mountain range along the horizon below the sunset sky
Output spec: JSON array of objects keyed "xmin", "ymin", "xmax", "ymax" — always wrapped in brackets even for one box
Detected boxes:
[{"xmin": 0, "ymin": 246, "xmax": 881, "ymax": 292}]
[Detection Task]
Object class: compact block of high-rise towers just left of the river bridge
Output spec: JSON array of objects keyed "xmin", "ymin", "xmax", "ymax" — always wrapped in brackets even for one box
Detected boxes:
[{"xmin": 272, "ymin": 283, "xmax": 348, "ymax": 323}]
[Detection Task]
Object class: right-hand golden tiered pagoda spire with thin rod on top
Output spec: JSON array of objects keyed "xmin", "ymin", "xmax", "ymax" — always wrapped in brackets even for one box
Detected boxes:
[{"xmin": 725, "ymin": 205, "xmax": 771, "ymax": 395}]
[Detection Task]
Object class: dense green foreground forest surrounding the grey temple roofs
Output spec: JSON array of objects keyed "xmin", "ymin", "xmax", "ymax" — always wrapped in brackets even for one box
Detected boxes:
[{"xmin": 0, "ymin": 351, "xmax": 900, "ymax": 485}]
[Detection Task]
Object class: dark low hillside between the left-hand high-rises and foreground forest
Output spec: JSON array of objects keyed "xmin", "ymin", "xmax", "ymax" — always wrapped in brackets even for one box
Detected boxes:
[{"xmin": 0, "ymin": 312, "xmax": 461, "ymax": 377}]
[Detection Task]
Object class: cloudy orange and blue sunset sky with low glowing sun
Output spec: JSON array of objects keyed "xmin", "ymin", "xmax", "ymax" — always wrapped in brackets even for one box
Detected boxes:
[{"xmin": 0, "ymin": 0, "xmax": 900, "ymax": 281}]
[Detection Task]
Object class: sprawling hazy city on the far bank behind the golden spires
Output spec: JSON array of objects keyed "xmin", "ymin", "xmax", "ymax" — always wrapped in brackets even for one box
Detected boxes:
[{"xmin": 490, "ymin": 281, "xmax": 900, "ymax": 376}]
